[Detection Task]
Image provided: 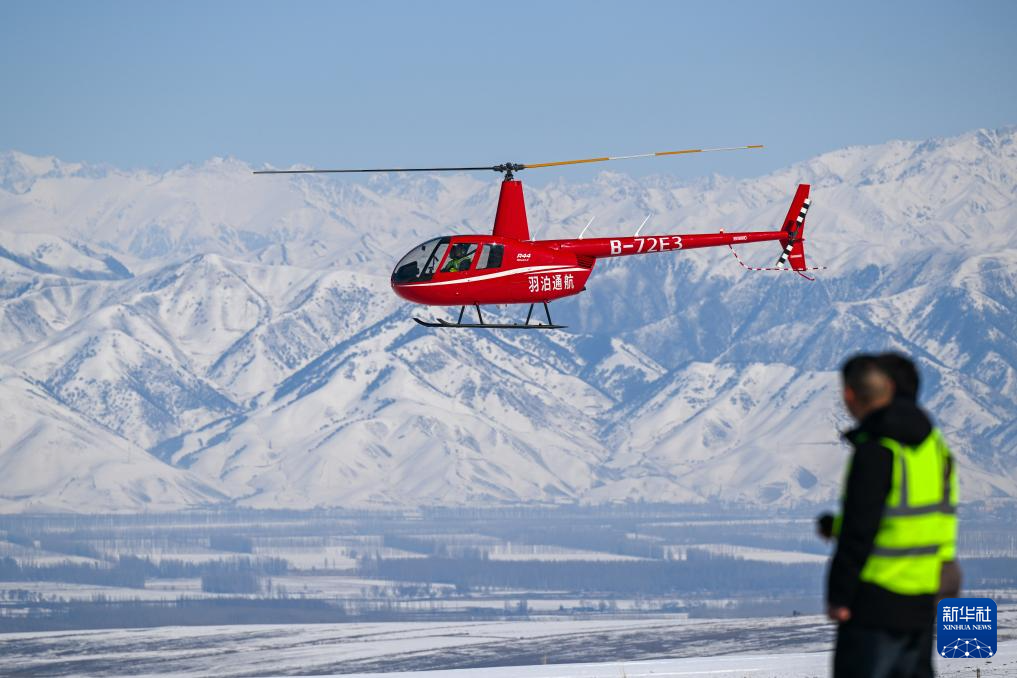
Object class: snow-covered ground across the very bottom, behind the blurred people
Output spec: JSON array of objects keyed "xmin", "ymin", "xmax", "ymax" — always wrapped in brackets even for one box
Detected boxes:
[{"xmin": 0, "ymin": 607, "xmax": 1017, "ymax": 678}]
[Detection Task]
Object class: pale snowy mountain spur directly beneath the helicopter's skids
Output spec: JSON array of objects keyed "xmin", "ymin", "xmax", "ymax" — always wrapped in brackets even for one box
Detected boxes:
[{"xmin": 160, "ymin": 314, "xmax": 610, "ymax": 506}]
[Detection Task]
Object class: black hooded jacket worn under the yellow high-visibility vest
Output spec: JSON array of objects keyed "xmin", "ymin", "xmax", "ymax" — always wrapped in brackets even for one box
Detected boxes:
[{"xmin": 827, "ymin": 399, "xmax": 936, "ymax": 630}]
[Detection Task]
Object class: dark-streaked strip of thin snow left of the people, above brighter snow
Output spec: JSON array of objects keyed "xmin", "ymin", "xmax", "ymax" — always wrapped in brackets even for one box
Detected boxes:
[{"xmin": 0, "ymin": 617, "xmax": 832, "ymax": 676}]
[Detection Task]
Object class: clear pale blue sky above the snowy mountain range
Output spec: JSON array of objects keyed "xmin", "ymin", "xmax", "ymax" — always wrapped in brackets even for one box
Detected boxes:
[{"xmin": 0, "ymin": 1, "xmax": 1017, "ymax": 181}]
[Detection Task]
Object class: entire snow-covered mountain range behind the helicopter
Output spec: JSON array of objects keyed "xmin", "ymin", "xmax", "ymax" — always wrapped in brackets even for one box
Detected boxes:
[{"xmin": 0, "ymin": 128, "xmax": 1017, "ymax": 510}]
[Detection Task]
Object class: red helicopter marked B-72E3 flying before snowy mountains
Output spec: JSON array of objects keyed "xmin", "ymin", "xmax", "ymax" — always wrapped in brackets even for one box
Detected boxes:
[{"xmin": 254, "ymin": 145, "xmax": 810, "ymax": 329}]
